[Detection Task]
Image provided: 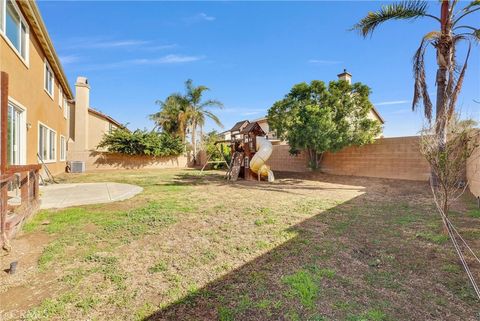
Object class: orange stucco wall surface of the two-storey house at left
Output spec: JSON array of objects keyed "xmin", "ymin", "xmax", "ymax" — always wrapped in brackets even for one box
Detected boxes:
[{"xmin": 0, "ymin": 1, "xmax": 69, "ymax": 174}]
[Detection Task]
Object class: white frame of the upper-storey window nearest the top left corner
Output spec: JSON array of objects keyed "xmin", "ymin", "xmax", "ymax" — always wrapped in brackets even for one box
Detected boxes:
[{"xmin": 0, "ymin": 0, "xmax": 30, "ymax": 68}]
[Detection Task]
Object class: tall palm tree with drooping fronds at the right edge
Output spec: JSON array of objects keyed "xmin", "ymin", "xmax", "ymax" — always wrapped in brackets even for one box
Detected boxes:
[{"xmin": 353, "ymin": 0, "xmax": 480, "ymax": 148}]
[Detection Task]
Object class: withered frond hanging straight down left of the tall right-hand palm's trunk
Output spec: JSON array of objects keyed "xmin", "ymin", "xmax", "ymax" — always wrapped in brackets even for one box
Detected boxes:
[{"xmin": 412, "ymin": 37, "xmax": 433, "ymax": 121}]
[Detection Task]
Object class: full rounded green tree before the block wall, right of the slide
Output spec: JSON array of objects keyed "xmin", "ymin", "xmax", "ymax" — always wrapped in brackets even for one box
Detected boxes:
[{"xmin": 268, "ymin": 80, "xmax": 381, "ymax": 169}]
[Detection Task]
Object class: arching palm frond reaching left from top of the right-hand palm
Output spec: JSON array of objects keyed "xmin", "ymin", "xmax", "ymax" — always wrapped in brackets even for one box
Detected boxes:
[{"xmin": 352, "ymin": 0, "xmax": 429, "ymax": 37}]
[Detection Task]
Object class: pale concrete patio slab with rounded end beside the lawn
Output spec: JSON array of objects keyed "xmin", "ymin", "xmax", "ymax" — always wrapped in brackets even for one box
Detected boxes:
[{"xmin": 40, "ymin": 183, "xmax": 143, "ymax": 209}]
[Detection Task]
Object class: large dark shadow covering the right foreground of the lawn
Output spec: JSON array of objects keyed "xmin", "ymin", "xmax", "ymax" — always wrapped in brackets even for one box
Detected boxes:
[{"xmin": 144, "ymin": 174, "xmax": 479, "ymax": 321}]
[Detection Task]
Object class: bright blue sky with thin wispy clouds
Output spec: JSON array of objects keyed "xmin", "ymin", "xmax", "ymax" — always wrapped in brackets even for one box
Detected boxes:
[{"xmin": 39, "ymin": 0, "xmax": 480, "ymax": 137}]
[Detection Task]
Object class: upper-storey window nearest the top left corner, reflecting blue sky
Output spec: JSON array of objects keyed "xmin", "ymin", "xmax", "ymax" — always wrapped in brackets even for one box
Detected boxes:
[{"xmin": 0, "ymin": 0, "xmax": 29, "ymax": 62}]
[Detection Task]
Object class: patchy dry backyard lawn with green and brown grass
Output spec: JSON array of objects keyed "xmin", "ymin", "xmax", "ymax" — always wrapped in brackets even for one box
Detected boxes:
[{"xmin": 0, "ymin": 170, "xmax": 480, "ymax": 321}]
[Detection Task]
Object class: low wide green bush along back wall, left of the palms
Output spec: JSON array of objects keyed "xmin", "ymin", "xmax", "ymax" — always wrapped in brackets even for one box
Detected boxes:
[{"xmin": 98, "ymin": 128, "xmax": 185, "ymax": 157}]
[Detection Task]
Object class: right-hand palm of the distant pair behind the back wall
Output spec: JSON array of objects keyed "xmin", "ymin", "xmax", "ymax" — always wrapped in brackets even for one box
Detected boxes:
[{"xmin": 183, "ymin": 79, "xmax": 223, "ymax": 163}]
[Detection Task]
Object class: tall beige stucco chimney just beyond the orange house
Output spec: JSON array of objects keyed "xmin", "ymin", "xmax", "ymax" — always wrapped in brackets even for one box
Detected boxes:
[{"xmin": 74, "ymin": 77, "xmax": 90, "ymax": 151}]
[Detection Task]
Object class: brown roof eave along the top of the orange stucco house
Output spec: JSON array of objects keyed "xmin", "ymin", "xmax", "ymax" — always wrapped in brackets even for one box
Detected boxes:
[{"xmin": 17, "ymin": 1, "xmax": 73, "ymax": 99}]
